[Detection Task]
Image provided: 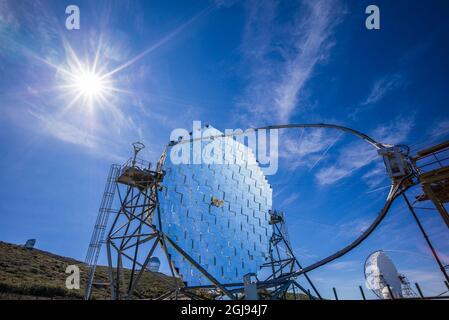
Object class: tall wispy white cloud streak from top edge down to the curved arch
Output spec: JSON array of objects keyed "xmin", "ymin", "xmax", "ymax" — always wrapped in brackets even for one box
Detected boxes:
[{"xmin": 239, "ymin": 1, "xmax": 344, "ymax": 122}]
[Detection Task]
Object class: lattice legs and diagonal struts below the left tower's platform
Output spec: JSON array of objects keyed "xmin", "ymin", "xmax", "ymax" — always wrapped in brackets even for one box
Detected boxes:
[{"xmin": 106, "ymin": 180, "xmax": 238, "ymax": 299}]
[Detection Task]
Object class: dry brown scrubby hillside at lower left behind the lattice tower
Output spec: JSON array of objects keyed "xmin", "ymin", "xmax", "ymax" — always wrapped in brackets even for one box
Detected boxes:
[{"xmin": 0, "ymin": 241, "xmax": 175, "ymax": 299}]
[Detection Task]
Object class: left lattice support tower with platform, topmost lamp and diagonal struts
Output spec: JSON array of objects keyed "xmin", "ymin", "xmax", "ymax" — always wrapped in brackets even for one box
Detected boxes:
[{"xmin": 106, "ymin": 144, "xmax": 235, "ymax": 299}]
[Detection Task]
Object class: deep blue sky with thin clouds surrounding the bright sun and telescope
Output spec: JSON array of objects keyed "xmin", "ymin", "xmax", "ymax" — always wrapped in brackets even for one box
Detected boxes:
[{"xmin": 0, "ymin": 0, "xmax": 449, "ymax": 298}]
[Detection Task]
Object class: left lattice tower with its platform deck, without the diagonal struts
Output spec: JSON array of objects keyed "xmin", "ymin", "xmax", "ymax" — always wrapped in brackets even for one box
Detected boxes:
[{"xmin": 106, "ymin": 166, "xmax": 169, "ymax": 299}]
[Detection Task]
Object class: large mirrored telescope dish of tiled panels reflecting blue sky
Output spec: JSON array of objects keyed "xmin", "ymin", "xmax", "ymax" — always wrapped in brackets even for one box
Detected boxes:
[{"xmin": 159, "ymin": 127, "xmax": 272, "ymax": 286}]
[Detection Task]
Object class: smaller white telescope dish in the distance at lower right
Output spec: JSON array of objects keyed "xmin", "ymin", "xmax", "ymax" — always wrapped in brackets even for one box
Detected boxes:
[{"xmin": 365, "ymin": 250, "xmax": 403, "ymax": 299}]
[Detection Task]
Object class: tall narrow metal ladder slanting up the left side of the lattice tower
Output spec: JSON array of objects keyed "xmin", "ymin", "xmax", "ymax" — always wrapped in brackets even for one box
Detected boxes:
[{"xmin": 84, "ymin": 164, "xmax": 121, "ymax": 300}]
